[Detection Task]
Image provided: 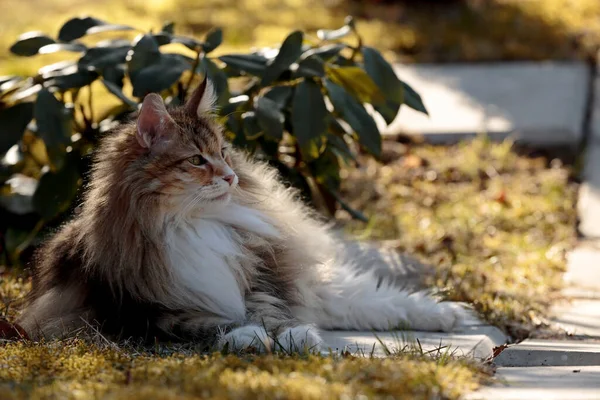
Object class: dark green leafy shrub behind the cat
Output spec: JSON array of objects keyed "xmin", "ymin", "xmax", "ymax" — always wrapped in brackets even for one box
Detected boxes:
[{"xmin": 0, "ymin": 17, "xmax": 426, "ymax": 263}]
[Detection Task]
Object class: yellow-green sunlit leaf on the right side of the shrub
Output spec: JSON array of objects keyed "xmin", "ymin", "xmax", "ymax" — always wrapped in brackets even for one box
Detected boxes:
[{"xmin": 326, "ymin": 65, "xmax": 384, "ymax": 104}]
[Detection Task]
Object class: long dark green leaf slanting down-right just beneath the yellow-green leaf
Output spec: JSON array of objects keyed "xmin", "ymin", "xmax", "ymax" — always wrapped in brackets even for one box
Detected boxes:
[{"xmin": 325, "ymin": 79, "xmax": 381, "ymax": 157}]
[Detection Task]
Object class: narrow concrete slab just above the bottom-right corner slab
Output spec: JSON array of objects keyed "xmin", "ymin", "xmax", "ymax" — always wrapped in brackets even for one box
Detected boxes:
[{"xmin": 494, "ymin": 340, "xmax": 600, "ymax": 367}]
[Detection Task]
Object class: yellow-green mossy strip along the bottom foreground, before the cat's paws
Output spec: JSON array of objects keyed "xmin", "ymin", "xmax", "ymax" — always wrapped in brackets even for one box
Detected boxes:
[{"xmin": 0, "ymin": 340, "xmax": 486, "ymax": 399}]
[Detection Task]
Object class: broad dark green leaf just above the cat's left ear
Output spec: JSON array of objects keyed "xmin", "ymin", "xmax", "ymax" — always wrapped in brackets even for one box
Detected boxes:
[{"xmin": 129, "ymin": 54, "xmax": 191, "ymax": 98}]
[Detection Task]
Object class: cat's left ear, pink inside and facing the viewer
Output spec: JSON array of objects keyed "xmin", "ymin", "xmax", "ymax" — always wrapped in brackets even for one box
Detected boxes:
[{"xmin": 135, "ymin": 93, "xmax": 177, "ymax": 149}]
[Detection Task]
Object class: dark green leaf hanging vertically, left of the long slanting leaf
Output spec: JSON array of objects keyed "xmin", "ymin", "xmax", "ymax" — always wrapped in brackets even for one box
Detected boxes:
[{"xmin": 291, "ymin": 80, "xmax": 329, "ymax": 160}]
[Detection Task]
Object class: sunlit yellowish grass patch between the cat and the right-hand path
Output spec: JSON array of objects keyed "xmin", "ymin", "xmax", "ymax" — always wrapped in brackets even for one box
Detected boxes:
[{"xmin": 339, "ymin": 137, "xmax": 577, "ymax": 340}]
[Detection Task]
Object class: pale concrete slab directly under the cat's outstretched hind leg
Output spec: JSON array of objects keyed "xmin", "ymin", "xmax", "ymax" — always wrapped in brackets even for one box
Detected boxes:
[{"xmin": 321, "ymin": 325, "xmax": 506, "ymax": 359}]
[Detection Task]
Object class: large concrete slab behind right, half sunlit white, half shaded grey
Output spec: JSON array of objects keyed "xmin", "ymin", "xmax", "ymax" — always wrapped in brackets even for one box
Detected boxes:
[{"xmin": 382, "ymin": 62, "xmax": 589, "ymax": 146}]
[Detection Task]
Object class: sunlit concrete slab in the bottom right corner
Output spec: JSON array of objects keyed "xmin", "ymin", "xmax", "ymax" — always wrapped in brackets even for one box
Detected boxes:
[{"xmin": 465, "ymin": 366, "xmax": 600, "ymax": 400}]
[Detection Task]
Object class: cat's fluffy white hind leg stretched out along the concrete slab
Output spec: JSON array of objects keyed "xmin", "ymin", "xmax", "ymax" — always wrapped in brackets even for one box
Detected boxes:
[{"xmin": 294, "ymin": 241, "xmax": 468, "ymax": 331}]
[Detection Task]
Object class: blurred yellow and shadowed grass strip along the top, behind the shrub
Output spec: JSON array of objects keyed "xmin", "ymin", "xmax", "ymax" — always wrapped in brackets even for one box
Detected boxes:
[{"xmin": 0, "ymin": 0, "xmax": 600, "ymax": 75}]
